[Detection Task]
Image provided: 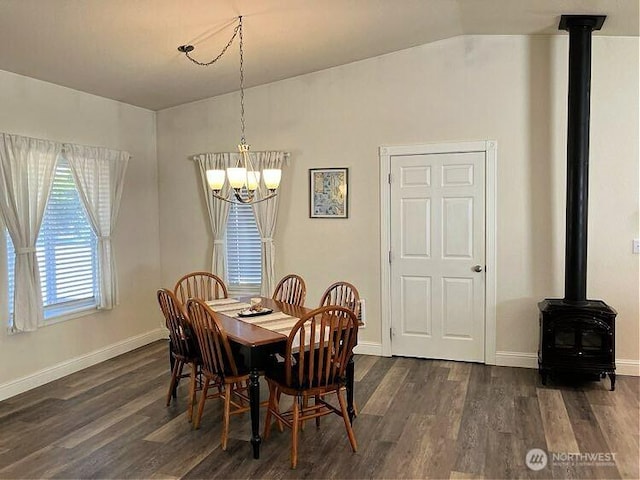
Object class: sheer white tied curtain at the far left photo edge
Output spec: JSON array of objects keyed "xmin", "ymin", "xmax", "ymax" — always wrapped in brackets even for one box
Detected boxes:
[{"xmin": 0, "ymin": 133, "xmax": 61, "ymax": 332}]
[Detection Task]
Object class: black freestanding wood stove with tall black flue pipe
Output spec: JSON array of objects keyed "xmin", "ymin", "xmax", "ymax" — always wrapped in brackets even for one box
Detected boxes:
[{"xmin": 538, "ymin": 15, "xmax": 616, "ymax": 390}]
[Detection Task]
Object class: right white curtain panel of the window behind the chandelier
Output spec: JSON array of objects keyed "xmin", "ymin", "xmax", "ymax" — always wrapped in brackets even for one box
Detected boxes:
[{"xmin": 252, "ymin": 152, "xmax": 286, "ymax": 297}]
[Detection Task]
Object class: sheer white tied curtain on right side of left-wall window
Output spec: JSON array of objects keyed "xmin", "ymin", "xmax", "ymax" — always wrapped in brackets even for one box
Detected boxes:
[{"xmin": 64, "ymin": 144, "xmax": 131, "ymax": 310}]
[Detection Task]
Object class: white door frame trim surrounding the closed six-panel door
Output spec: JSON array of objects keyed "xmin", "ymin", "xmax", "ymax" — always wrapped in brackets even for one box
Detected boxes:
[{"xmin": 378, "ymin": 140, "xmax": 498, "ymax": 365}]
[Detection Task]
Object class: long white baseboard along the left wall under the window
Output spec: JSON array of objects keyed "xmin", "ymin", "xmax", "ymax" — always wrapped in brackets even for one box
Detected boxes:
[{"xmin": 0, "ymin": 328, "xmax": 168, "ymax": 401}]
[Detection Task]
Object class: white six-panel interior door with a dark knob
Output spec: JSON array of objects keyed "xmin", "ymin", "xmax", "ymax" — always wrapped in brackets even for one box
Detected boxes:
[{"xmin": 390, "ymin": 152, "xmax": 485, "ymax": 362}]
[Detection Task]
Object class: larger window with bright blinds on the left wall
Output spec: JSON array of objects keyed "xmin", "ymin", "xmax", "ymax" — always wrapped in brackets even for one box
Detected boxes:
[{"xmin": 6, "ymin": 157, "xmax": 98, "ymax": 320}]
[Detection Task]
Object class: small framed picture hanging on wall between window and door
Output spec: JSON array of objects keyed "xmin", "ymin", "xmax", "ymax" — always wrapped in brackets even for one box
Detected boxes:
[{"xmin": 309, "ymin": 168, "xmax": 349, "ymax": 218}]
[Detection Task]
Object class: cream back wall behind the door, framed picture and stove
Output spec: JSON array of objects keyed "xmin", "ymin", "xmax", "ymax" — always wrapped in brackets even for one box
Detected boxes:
[{"xmin": 157, "ymin": 35, "xmax": 639, "ymax": 370}]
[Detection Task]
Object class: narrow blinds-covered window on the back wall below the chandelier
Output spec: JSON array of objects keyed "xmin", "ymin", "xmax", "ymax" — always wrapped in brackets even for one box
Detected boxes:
[{"xmin": 227, "ymin": 203, "xmax": 262, "ymax": 292}]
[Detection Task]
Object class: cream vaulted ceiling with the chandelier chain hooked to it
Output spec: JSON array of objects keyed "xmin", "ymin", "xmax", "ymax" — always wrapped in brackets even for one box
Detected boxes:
[{"xmin": 0, "ymin": 0, "xmax": 640, "ymax": 110}]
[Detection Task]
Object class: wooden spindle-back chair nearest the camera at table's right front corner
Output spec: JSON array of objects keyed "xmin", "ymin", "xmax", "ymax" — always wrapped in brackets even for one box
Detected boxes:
[{"xmin": 264, "ymin": 305, "xmax": 358, "ymax": 468}]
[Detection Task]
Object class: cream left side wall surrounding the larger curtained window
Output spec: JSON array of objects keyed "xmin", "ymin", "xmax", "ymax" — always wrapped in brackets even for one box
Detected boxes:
[{"xmin": 0, "ymin": 71, "xmax": 161, "ymax": 399}]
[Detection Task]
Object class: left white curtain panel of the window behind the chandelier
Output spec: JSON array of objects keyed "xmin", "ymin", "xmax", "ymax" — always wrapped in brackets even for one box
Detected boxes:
[{"xmin": 195, "ymin": 153, "xmax": 236, "ymax": 284}]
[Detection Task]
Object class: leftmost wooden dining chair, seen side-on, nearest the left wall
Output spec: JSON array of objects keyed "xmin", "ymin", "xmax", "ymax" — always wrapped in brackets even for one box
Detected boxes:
[{"xmin": 157, "ymin": 288, "xmax": 202, "ymax": 421}]
